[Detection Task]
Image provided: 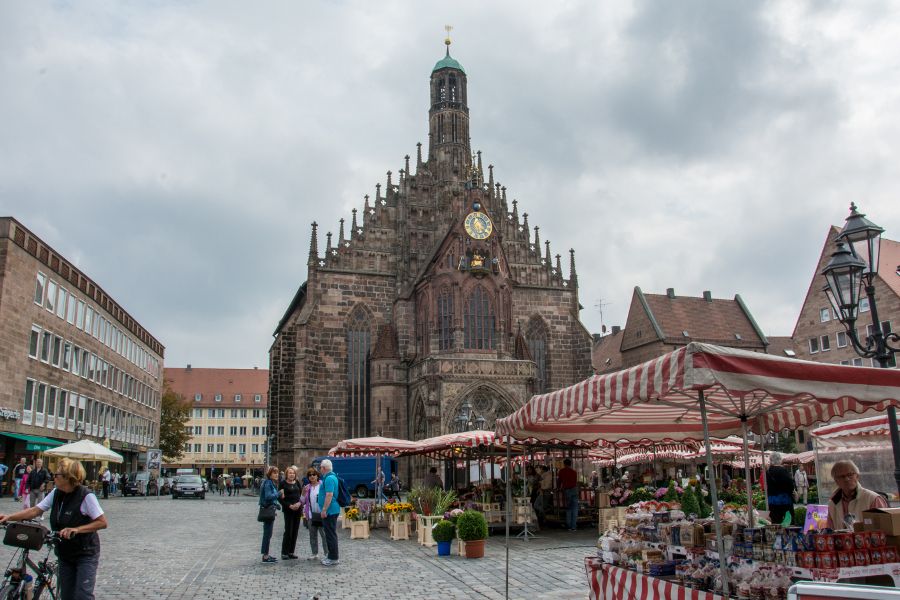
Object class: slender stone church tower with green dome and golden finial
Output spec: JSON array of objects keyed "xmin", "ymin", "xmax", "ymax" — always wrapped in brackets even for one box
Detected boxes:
[{"xmin": 428, "ymin": 30, "xmax": 472, "ymax": 181}]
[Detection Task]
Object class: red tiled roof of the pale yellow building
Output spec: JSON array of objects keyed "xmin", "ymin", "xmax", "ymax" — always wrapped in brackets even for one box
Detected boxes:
[{"xmin": 166, "ymin": 367, "xmax": 269, "ymax": 408}]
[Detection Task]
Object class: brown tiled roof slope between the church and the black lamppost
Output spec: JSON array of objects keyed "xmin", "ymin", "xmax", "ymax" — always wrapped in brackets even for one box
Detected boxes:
[{"xmin": 644, "ymin": 294, "xmax": 764, "ymax": 347}]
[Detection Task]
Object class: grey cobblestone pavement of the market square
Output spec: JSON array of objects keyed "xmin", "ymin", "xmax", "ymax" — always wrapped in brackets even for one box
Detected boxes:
[{"xmin": 0, "ymin": 495, "xmax": 597, "ymax": 600}]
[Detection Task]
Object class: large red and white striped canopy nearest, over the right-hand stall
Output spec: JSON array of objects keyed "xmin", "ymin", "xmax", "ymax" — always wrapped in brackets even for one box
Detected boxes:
[{"xmin": 497, "ymin": 342, "xmax": 900, "ymax": 442}]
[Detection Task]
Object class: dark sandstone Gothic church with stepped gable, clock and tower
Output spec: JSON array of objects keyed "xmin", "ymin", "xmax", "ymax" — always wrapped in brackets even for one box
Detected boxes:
[{"xmin": 269, "ymin": 40, "xmax": 591, "ymax": 466}]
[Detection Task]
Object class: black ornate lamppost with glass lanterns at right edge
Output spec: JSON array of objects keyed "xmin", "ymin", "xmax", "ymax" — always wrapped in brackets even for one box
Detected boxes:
[{"xmin": 822, "ymin": 203, "xmax": 900, "ymax": 492}]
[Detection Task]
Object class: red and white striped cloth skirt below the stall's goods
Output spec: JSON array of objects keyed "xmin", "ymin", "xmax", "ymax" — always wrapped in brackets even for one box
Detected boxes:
[{"xmin": 584, "ymin": 556, "xmax": 726, "ymax": 600}]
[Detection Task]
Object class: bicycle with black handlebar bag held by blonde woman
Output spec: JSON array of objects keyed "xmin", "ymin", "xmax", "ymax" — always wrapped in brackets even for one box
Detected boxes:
[{"xmin": 0, "ymin": 521, "xmax": 59, "ymax": 600}]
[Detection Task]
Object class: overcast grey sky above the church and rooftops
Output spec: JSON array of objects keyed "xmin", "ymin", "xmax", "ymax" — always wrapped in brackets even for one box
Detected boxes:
[{"xmin": 0, "ymin": 0, "xmax": 900, "ymax": 367}]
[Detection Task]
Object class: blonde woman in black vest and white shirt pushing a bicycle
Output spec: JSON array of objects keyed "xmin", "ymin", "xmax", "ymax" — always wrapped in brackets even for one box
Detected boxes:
[{"xmin": 0, "ymin": 458, "xmax": 108, "ymax": 600}]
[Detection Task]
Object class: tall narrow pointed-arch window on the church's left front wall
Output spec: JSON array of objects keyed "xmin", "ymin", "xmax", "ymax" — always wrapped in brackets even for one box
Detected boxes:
[{"xmin": 347, "ymin": 310, "xmax": 372, "ymax": 438}]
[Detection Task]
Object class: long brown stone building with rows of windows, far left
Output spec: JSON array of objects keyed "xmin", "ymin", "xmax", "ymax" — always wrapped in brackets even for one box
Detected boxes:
[{"xmin": 0, "ymin": 217, "xmax": 164, "ymax": 478}]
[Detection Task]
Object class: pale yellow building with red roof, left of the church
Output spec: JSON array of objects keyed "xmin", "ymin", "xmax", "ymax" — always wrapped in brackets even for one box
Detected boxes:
[{"xmin": 165, "ymin": 365, "xmax": 268, "ymax": 478}]
